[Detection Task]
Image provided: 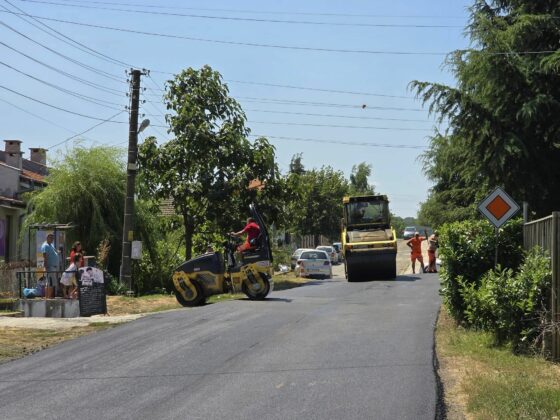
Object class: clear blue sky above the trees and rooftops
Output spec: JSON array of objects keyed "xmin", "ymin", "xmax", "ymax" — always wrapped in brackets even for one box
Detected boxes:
[{"xmin": 0, "ymin": 0, "xmax": 470, "ymax": 217}]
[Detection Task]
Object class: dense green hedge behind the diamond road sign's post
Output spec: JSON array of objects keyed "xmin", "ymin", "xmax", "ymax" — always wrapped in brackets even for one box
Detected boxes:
[{"xmin": 439, "ymin": 219, "xmax": 523, "ymax": 322}]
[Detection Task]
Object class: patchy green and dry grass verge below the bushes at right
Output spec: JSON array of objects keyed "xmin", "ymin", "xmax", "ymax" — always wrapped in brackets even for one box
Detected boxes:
[{"xmin": 436, "ymin": 309, "xmax": 560, "ymax": 419}]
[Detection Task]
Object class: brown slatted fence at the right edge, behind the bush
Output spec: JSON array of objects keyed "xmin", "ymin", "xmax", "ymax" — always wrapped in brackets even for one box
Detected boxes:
[{"xmin": 523, "ymin": 212, "xmax": 560, "ymax": 360}]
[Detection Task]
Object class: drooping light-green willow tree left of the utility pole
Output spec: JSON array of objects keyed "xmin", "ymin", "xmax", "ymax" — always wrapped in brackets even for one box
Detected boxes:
[{"xmin": 26, "ymin": 145, "xmax": 126, "ymax": 272}]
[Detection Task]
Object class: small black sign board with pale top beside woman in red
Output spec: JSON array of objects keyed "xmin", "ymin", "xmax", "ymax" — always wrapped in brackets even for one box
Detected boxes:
[{"xmin": 78, "ymin": 267, "xmax": 107, "ymax": 316}]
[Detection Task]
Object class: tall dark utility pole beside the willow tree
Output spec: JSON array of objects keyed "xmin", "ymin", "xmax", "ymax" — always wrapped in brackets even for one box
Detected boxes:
[{"xmin": 120, "ymin": 69, "xmax": 148, "ymax": 291}]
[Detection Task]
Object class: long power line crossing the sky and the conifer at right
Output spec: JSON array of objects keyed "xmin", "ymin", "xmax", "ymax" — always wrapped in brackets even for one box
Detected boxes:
[{"xmin": 0, "ymin": 10, "xmax": 556, "ymax": 56}]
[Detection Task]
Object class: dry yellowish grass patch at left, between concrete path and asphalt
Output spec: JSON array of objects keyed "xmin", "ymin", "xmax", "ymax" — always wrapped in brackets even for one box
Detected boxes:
[{"xmin": 0, "ymin": 322, "xmax": 114, "ymax": 363}]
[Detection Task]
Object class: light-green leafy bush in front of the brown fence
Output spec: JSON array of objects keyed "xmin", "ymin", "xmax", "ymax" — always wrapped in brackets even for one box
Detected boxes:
[{"xmin": 463, "ymin": 249, "xmax": 552, "ymax": 351}]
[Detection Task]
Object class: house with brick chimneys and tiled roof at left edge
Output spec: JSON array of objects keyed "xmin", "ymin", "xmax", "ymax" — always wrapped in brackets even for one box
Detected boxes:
[{"xmin": 0, "ymin": 140, "xmax": 48, "ymax": 262}]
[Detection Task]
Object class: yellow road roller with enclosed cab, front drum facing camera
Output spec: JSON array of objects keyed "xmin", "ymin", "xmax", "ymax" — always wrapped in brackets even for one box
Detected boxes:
[{"xmin": 342, "ymin": 195, "xmax": 397, "ymax": 282}]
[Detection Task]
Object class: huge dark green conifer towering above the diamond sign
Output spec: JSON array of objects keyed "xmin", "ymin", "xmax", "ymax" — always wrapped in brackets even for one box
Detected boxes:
[{"xmin": 412, "ymin": 0, "xmax": 560, "ymax": 220}]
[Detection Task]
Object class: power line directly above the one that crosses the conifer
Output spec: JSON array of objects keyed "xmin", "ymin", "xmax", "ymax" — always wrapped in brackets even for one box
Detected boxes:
[{"xmin": 20, "ymin": 0, "xmax": 463, "ymax": 29}]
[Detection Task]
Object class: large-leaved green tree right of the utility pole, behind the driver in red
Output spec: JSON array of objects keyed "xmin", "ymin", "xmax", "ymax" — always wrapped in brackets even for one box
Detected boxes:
[{"xmin": 139, "ymin": 66, "xmax": 278, "ymax": 259}]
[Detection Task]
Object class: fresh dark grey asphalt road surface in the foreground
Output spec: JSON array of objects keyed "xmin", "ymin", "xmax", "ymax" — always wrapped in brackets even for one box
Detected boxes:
[{"xmin": 0, "ymin": 266, "xmax": 440, "ymax": 420}]
